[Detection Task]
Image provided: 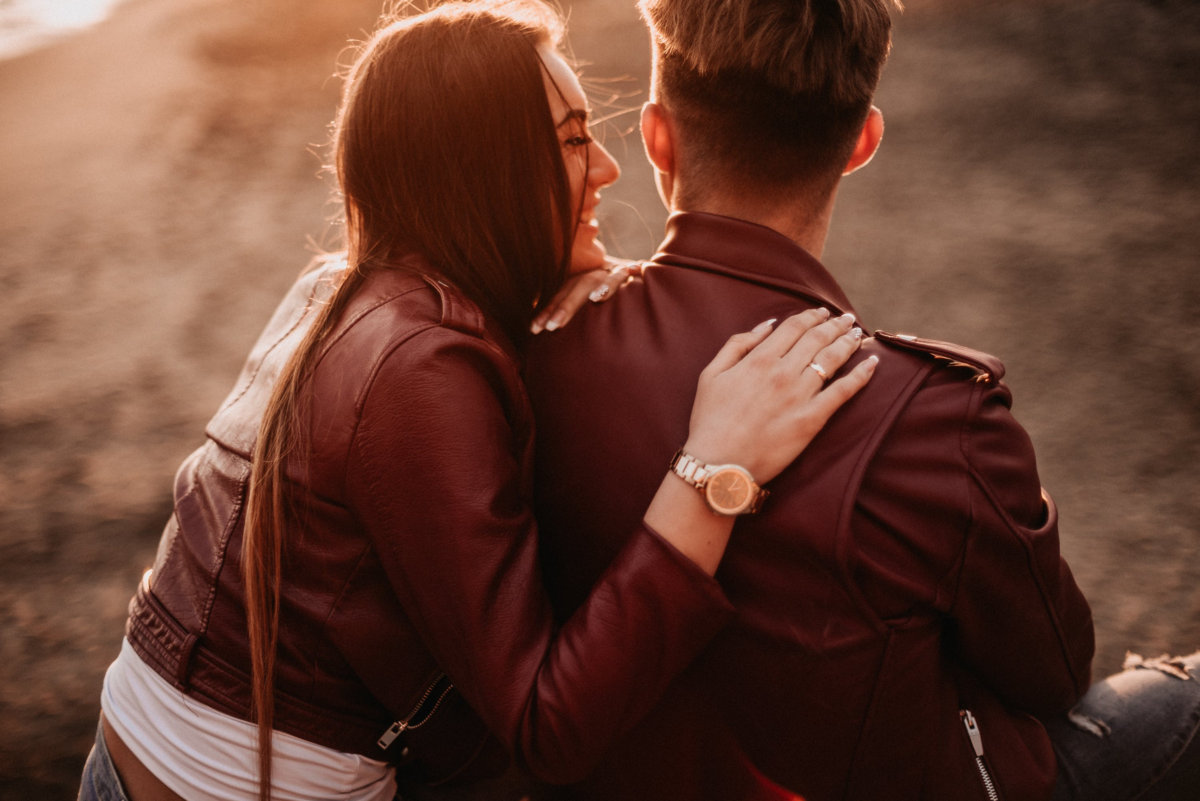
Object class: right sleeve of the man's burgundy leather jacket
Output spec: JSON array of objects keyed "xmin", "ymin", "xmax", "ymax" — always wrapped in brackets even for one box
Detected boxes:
[{"xmin": 950, "ymin": 384, "xmax": 1094, "ymax": 715}]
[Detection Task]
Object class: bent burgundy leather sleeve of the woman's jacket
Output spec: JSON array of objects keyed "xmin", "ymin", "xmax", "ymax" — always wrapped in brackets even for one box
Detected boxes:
[{"xmin": 347, "ymin": 327, "xmax": 732, "ymax": 783}]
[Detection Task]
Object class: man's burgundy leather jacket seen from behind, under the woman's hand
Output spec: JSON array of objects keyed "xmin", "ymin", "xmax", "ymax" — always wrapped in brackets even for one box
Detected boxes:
[{"xmin": 527, "ymin": 213, "xmax": 1093, "ymax": 801}]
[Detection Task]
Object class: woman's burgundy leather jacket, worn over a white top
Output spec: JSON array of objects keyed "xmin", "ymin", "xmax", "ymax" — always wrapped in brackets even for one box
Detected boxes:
[{"xmin": 126, "ymin": 260, "xmax": 732, "ymax": 783}]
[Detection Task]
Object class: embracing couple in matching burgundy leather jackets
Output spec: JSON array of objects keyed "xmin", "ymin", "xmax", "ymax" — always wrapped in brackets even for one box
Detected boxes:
[{"xmin": 80, "ymin": 0, "xmax": 1200, "ymax": 801}]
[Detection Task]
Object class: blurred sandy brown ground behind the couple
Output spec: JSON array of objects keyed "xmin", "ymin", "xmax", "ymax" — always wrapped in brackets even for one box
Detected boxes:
[{"xmin": 0, "ymin": 0, "xmax": 1200, "ymax": 799}]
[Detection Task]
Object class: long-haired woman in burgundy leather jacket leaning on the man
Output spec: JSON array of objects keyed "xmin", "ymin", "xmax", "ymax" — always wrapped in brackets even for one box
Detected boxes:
[{"xmin": 80, "ymin": 0, "xmax": 872, "ymax": 801}]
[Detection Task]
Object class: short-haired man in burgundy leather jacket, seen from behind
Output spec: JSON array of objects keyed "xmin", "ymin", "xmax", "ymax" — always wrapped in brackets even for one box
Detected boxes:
[{"xmin": 527, "ymin": 0, "xmax": 1093, "ymax": 801}]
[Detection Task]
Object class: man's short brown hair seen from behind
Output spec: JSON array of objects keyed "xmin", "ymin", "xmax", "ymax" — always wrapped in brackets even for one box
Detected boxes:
[{"xmin": 638, "ymin": 0, "xmax": 892, "ymax": 199}]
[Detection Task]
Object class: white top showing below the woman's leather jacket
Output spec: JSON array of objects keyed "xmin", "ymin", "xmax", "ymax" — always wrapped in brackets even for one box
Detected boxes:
[{"xmin": 101, "ymin": 640, "xmax": 396, "ymax": 801}]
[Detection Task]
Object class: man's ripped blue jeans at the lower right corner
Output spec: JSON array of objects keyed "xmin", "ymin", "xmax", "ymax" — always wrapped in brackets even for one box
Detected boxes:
[{"xmin": 1043, "ymin": 652, "xmax": 1200, "ymax": 801}]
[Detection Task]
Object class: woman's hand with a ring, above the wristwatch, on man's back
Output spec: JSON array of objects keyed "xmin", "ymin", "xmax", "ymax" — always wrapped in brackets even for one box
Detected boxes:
[{"xmin": 684, "ymin": 308, "xmax": 878, "ymax": 483}]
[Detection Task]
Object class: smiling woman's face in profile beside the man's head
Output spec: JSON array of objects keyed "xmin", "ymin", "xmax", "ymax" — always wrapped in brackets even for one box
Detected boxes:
[{"xmin": 539, "ymin": 44, "xmax": 620, "ymax": 272}]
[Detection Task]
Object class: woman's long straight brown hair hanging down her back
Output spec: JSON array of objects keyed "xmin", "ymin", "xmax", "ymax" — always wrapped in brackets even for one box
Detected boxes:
[{"xmin": 242, "ymin": 0, "xmax": 575, "ymax": 801}]
